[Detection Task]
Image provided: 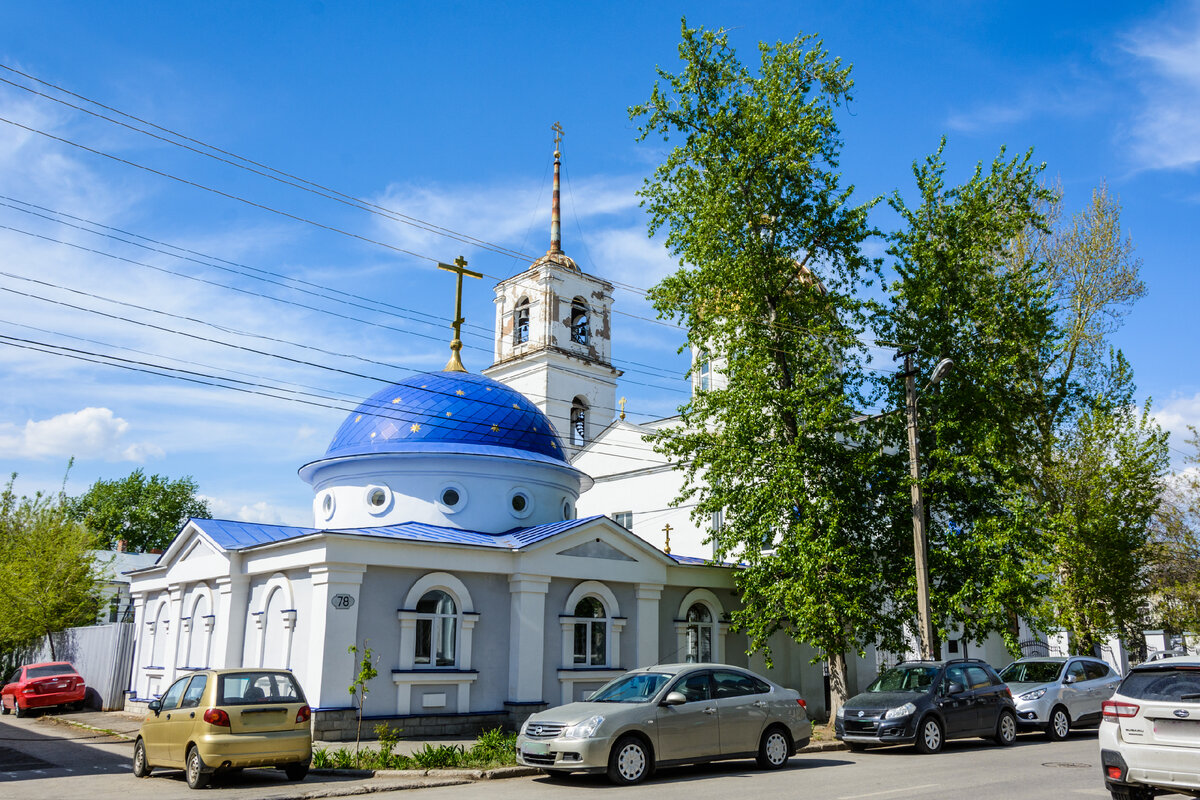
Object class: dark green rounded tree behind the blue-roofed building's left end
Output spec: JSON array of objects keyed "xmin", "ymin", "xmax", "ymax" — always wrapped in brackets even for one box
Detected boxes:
[{"xmin": 68, "ymin": 469, "xmax": 211, "ymax": 552}]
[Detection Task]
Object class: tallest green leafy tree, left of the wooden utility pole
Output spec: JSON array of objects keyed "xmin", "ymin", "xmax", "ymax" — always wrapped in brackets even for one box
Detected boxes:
[{"xmin": 630, "ymin": 22, "xmax": 911, "ymax": 706}]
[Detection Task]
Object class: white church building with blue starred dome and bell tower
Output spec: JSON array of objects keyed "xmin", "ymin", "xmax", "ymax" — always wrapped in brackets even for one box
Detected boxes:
[{"xmin": 127, "ymin": 140, "xmax": 835, "ymax": 739}]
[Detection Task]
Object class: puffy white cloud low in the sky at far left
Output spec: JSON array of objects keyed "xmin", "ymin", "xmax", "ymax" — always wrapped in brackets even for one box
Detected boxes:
[{"xmin": 0, "ymin": 408, "xmax": 164, "ymax": 463}]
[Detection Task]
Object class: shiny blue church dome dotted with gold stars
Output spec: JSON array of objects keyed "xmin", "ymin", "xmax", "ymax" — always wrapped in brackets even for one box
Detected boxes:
[{"xmin": 314, "ymin": 372, "xmax": 568, "ymax": 464}]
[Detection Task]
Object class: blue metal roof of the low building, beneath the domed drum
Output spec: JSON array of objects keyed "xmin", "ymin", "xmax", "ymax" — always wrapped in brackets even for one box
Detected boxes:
[{"xmin": 191, "ymin": 515, "xmax": 602, "ymax": 551}]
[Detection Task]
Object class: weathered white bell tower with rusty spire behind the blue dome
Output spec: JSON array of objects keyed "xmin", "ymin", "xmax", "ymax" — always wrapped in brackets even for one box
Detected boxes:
[{"xmin": 484, "ymin": 122, "xmax": 622, "ymax": 456}]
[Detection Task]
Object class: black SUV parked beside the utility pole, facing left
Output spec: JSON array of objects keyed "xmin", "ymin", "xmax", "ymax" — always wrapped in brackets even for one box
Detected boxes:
[{"xmin": 834, "ymin": 658, "xmax": 1016, "ymax": 753}]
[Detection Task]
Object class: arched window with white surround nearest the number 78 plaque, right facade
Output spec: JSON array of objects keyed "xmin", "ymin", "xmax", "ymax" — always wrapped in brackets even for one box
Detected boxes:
[{"xmin": 391, "ymin": 572, "xmax": 480, "ymax": 715}]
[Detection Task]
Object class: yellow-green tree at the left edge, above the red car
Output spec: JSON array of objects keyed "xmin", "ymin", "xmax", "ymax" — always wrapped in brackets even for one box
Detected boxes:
[{"xmin": 0, "ymin": 474, "xmax": 102, "ymax": 658}]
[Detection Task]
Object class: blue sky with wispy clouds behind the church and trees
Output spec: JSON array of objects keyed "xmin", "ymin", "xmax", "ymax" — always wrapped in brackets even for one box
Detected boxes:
[{"xmin": 0, "ymin": 0, "xmax": 1200, "ymax": 524}]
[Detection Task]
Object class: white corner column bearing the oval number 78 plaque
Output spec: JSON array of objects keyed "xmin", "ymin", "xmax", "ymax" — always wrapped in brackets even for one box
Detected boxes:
[{"xmin": 299, "ymin": 564, "xmax": 367, "ymax": 708}]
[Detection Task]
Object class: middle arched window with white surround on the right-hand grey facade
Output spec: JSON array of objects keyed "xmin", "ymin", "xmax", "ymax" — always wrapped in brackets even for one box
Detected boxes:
[{"xmin": 558, "ymin": 581, "xmax": 628, "ymax": 703}]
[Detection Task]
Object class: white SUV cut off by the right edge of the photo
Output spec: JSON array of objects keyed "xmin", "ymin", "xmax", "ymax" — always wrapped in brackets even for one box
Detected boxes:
[{"xmin": 1099, "ymin": 656, "xmax": 1200, "ymax": 800}]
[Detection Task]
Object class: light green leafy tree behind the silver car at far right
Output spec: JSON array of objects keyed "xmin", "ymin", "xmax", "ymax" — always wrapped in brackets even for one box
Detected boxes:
[{"xmin": 1045, "ymin": 362, "xmax": 1169, "ymax": 652}]
